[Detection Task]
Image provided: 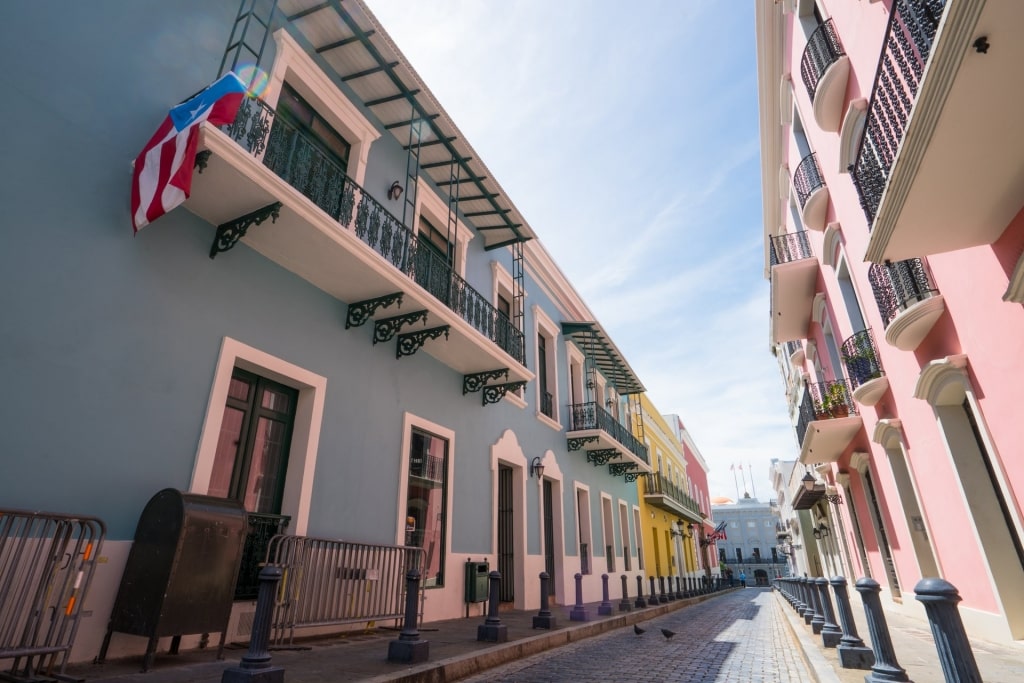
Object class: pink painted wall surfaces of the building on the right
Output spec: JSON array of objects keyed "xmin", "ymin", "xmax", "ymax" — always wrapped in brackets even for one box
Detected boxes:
[{"xmin": 779, "ymin": 2, "xmax": 1024, "ymax": 611}]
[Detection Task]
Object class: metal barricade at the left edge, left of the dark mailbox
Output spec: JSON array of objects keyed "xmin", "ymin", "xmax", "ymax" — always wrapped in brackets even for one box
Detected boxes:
[{"xmin": 0, "ymin": 509, "xmax": 106, "ymax": 681}]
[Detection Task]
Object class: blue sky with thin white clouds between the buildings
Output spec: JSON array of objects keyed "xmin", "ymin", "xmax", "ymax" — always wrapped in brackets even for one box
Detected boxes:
[{"xmin": 366, "ymin": 0, "xmax": 797, "ymax": 501}]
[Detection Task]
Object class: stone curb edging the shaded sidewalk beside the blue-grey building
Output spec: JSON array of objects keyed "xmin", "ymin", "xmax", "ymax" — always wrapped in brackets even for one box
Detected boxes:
[{"xmin": 366, "ymin": 588, "xmax": 737, "ymax": 683}]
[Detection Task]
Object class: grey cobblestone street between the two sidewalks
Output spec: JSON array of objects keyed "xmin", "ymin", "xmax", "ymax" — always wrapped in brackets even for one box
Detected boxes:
[{"xmin": 465, "ymin": 589, "xmax": 811, "ymax": 683}]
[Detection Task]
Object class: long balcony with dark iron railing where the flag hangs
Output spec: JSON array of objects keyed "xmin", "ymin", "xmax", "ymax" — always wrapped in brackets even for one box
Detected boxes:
[{"xmin": 185, "ymin": 99, "xmax": 532, "ymax": 382}]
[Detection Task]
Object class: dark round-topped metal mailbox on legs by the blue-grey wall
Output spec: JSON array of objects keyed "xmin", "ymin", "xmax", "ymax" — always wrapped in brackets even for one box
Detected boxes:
[{"xmin": 98, "ymin": 488, "xmax": 247, "ymax": 671}]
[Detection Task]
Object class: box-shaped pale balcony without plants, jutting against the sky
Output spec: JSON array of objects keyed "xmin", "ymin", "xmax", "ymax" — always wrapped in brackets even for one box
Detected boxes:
[{"xmin": 769, "ymin": 230, "xmax": 818, "ymax": 344}]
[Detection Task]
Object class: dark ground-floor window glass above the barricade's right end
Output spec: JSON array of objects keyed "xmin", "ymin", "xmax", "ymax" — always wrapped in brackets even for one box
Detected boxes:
[{"xmin": 406, "ymin": 427, "xmax": 449, "ymax": 588}]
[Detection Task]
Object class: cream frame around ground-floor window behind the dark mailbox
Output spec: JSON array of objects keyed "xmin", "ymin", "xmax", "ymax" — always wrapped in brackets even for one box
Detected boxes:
[{"xmin": 188, "ymin": 337, "xmax": 327, "ymax": 536}]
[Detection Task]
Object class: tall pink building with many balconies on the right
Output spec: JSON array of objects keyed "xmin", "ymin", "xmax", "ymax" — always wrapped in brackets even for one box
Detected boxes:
[{"xmin": 757, "ymin": 0, "xmax": 1024, "ymax": 640}]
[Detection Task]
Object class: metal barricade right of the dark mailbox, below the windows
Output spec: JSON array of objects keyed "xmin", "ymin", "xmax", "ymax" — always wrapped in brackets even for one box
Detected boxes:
[{"xmin": 267, "ymin": 536, "xmax": 424, "ymax": 646}]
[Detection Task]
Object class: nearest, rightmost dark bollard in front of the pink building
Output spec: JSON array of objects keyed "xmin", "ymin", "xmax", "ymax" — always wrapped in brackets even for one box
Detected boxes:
[{"xmin": 913, "ymin": 579, "xmax": 981, "ymax": 683}]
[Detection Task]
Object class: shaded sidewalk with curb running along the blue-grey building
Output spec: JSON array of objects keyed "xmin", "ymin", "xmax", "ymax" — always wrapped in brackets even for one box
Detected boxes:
[{"xmin": 66, "ymin": 589, "xmax": 739, "ymax": 683}]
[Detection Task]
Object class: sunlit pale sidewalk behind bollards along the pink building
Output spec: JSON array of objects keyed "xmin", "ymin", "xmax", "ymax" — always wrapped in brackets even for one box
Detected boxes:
[{"xmin": 774, "ymin": 591, "xmax": 1024, "ymax": 683}]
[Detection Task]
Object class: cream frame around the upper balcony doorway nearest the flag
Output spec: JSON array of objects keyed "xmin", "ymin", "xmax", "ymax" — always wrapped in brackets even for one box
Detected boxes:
[{"xmin": 262, "ymin": 29, "xmax": 381, "ymax": 186}]
